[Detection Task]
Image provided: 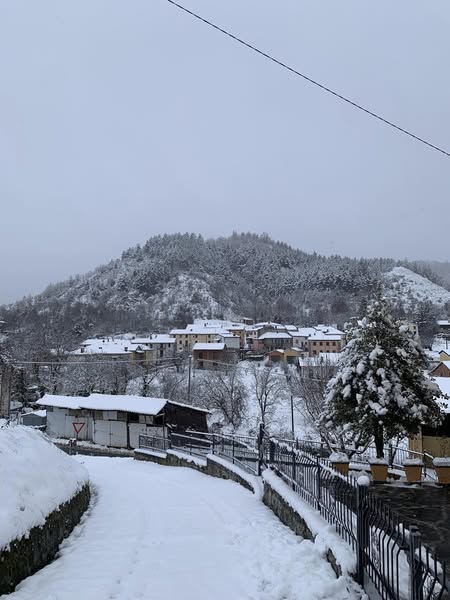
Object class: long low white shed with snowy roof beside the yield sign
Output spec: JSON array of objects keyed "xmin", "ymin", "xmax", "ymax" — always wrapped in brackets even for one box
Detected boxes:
[{"xmin": 36, "ymin": 394, "xmax": 208, "ymax": 448}]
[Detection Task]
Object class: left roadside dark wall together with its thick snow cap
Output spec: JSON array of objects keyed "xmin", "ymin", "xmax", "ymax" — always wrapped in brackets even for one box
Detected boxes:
[{"xmin": 0, "ymin": 423, "xmax": 90, "ymax": 594}]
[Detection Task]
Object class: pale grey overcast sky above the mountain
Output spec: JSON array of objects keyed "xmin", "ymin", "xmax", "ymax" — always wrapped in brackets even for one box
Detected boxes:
[{"xmin": 0, "ymin": 0, "xmax": 450, "ymax": 302}]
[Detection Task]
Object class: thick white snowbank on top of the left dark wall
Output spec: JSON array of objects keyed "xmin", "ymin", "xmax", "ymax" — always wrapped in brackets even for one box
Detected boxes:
[{"xmin": 0, "ymin": 425, "xmax": 88, "ymax": 550}]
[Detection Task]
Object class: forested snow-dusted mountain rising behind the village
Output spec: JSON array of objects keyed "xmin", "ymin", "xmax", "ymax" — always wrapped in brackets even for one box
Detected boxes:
[{"xmin": 0, "ymin": 233, "xmax": 445, "ymax": 354}]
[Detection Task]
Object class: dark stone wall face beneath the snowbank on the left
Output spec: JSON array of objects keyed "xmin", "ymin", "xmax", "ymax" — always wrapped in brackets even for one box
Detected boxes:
[{"xmin": 0, "ymin": 485, "xmax": 90, "ymax": 595}]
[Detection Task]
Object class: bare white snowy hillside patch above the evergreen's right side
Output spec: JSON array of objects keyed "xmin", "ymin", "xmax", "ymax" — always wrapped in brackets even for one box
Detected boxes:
[{"xmin": 384, "ymin": 267, "xmax": 450, "ymax": 308}]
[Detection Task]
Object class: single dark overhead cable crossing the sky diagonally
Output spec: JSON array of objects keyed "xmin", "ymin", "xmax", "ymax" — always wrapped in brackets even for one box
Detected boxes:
[{"xmin": 167, "ymin": 0, "xmax": 450, "ymax": 157}]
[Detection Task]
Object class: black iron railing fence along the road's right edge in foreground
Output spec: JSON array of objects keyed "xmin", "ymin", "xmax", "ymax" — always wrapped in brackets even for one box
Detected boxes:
[{"xmin": 264, "ymin": 438, "xmax": 449, "ymax": 600}]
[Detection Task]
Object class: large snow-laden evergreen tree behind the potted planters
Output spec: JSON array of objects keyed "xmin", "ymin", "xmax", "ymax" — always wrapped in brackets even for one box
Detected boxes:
[{"xmin": 321, "ymin": 296, "xmax": 440, "ymax": 458}]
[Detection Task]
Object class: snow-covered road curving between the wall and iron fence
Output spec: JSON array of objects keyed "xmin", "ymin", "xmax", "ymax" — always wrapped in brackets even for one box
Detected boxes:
[{"xmin": 2, "ymin": 456, "xmax": 356, "ymax": 600}]
